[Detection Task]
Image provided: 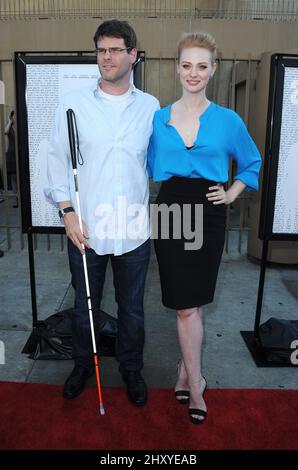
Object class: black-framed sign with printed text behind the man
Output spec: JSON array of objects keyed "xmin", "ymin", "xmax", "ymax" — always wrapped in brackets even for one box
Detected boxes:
[{"xmin": 15, "ymin": 51, "xmax": 145, "ymax": 233}]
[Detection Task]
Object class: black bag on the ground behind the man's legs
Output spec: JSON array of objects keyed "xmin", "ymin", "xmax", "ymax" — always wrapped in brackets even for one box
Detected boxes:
[{"xmin": 22, "ymin": 308, "xmax": 117, "ymax": 360}]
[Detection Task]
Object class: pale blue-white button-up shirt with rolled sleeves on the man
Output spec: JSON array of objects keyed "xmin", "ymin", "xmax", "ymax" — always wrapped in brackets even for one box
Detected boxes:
[{"xmin": 45, "ymin": 85, "xmax": 159, "ymax": 255}]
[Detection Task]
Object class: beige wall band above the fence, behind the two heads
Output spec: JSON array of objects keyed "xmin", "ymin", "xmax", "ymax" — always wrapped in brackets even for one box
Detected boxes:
[{"xmin": 0, "ymin": 18, "xmax": 298, "ymax": 60}]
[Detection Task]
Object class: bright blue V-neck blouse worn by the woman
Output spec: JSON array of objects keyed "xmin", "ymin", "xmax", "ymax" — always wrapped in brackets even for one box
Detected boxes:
[{"xmin": 148, "ymin": 101, "xmax": 262, "ymax": 191}]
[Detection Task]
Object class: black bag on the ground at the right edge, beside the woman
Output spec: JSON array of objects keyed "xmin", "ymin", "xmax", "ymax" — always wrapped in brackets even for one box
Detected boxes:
[{"xmin": 259, "ymin": 317, "xmax": 298, "ymax": 365}]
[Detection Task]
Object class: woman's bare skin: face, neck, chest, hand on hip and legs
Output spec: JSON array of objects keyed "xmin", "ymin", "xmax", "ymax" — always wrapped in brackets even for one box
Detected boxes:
[{"xmin": 169, "ymin": 47, "xmax": 246, "ymax": 419}]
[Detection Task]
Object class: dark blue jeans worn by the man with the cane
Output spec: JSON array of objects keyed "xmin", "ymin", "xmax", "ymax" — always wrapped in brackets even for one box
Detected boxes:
[{"xmin": 68, "ymin": 239, "xmax": 150, "ymax": 372}]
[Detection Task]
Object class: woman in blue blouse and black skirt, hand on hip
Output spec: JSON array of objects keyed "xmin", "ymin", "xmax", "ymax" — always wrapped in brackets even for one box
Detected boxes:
[{"xmin": 148, "ymin": 33, "xmax": 261, "ymax": 424}]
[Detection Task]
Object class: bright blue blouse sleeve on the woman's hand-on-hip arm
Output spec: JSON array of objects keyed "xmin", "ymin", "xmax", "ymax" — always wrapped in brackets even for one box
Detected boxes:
[{"xmin": 232, "ymin": 116, "xmax": 262, "ymax": 191}]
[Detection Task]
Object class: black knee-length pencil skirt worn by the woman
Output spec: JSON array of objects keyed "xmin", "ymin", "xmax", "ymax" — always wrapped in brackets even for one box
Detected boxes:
[{"xmin": 154, "ymin": 177, "xmax": 226, "ymax": 310}]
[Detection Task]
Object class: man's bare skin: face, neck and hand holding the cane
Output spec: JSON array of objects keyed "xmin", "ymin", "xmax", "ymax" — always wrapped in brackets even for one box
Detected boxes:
[{"xmin": 59, "ymin": 37, "xmax": 137, "ymax": 254}]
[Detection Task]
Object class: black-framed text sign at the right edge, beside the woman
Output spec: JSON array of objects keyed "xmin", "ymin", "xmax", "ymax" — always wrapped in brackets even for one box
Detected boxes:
[{"xmin": 259, "ymin": 54, "xmax": 298, "ymax": 241}]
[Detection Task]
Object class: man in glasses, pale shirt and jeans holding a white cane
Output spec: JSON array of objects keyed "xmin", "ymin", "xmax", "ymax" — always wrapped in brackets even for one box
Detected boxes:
[{"xmin": 46, "ymin": 20, "xmax": 159, "ymax": 405}]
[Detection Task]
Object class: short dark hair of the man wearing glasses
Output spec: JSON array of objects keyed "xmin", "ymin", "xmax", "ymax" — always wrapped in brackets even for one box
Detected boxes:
[{"xmin": 93, "ymin": 20, "xmax": 137, "ymax": 49}]
